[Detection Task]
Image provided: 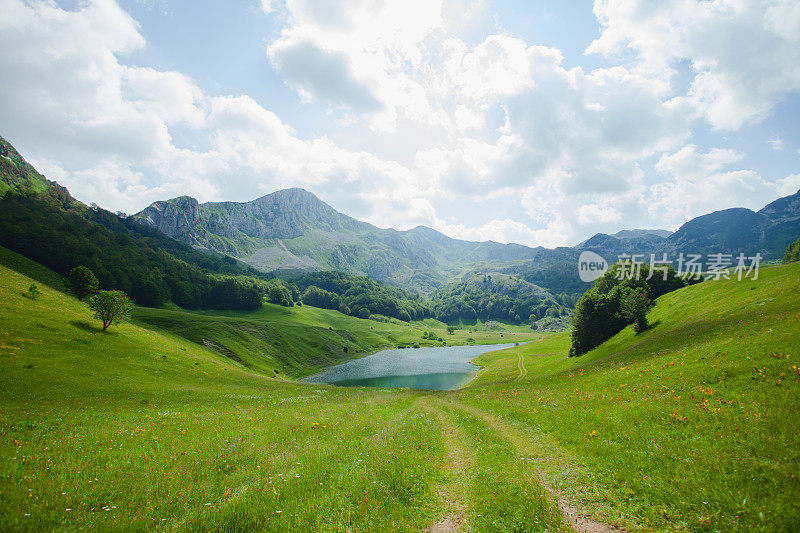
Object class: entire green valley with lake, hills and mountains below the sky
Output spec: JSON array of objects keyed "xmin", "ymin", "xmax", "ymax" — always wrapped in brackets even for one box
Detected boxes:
[{"xmin": 0, "ymin": 138, "xmax": 800, "ymax": 532}]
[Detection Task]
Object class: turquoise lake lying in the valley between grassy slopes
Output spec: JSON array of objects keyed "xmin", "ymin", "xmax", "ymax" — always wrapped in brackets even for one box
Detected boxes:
[{"xmin": 303, "ymin": 344, "xmax": 513, "ymax": 390}]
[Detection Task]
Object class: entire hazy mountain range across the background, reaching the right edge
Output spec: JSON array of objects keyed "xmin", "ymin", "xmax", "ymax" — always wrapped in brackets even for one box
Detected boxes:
[{"xmin": 133, "ymin": 188, "xmax": 800, "ymax": 293}]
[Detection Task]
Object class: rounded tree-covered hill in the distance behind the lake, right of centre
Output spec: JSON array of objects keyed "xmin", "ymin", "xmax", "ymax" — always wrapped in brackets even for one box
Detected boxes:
[{"xmin": 432, "ymin": 273, "xmax": 577, "ymax": 324}]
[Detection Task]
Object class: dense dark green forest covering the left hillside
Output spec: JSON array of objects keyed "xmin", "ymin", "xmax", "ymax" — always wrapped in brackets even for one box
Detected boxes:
[{"xmin": 0, "ymin": 186, "xmax": 262, "ymax": 309}]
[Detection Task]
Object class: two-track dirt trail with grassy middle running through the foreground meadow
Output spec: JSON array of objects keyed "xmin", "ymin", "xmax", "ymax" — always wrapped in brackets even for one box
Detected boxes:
[{"xmin": 417, "ymin": 390, "xmax": 624, "ymax": 533}]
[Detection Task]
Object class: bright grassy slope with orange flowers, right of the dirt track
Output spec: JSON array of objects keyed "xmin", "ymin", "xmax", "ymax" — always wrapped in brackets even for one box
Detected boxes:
[{"xmin": 456, "ymin": 264, "xmax": 800, "ymax": 530}]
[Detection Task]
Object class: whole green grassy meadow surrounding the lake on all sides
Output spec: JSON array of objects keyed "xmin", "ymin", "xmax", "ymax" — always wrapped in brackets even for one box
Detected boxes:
[{"xmin": 0, "ymin": 243, "xmax": 800, "ymax": 532}]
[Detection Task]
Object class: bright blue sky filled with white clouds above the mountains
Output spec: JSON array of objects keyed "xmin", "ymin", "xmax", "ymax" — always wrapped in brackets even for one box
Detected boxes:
[{"xmin": 0, "ymin": 0, "xmax": 800, "ymax": 247}]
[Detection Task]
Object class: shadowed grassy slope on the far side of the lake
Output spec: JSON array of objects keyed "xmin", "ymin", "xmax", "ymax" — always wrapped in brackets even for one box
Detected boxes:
[{"xmin": 134, "ymin": 304, "xmax": 535, "ymax": 378}]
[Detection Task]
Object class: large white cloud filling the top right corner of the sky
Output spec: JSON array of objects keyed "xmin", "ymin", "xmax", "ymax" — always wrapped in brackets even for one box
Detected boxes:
[{"xmin": 587, "ymin": 0, "xmax": 800, "ymax": 129}]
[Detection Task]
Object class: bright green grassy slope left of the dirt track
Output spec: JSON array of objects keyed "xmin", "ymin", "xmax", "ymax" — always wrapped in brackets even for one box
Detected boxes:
[{"xmin": 0, "ymin": 257, "xmax": 560, "ymax": 531}]
